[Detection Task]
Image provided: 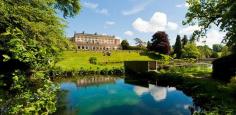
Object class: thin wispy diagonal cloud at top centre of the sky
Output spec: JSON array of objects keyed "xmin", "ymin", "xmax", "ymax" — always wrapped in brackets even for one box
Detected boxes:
[{"xmin": 122, "ymin": 0, "xmax": 154, "ymax": 16}]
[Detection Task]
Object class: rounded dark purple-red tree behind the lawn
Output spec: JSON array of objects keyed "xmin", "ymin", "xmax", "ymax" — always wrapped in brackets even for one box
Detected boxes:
[{"xmin": 150, "ymin": 31, "xmax": 170, "ymax": 55}]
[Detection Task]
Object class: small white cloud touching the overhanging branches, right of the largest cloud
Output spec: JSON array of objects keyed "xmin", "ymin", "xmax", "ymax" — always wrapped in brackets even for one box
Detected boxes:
[{"xmin": 179, "ymin": 25, "xmax": 201, "ymax": 35}]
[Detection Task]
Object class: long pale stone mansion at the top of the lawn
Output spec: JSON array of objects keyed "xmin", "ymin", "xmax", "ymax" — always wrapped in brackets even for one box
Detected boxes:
[{"xmin": 72, "ymin": 33, "xmax": 121, "ymax": 50}]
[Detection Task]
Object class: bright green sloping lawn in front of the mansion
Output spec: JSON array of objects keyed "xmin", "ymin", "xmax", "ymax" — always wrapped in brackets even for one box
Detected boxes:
[{"xmin": 56, "ymin": 51, "xmax": 153, "ymax": 70}]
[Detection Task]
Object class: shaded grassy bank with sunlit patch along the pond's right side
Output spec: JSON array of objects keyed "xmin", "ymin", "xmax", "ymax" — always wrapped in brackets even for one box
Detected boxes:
[{"xmin": 148, "ymin": 65, "xmax": 236, "ymax": 115}]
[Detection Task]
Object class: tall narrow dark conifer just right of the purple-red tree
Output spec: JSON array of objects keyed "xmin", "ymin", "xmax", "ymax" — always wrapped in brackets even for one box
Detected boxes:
[{"xmin": 174, "ymin": 35, "xmax": 182, "ymax": 59}]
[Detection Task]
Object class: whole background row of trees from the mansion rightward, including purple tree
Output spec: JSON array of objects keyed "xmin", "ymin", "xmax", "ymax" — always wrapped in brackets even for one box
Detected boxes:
[{"xmin": 121, "ymin": 31, "xmax": 231, "ymax": 59}]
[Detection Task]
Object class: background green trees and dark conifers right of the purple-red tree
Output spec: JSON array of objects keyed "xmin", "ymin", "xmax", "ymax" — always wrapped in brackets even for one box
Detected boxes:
[{"xmin": 171, "ymin": 35, "xmax": 230, "ymax": 59}]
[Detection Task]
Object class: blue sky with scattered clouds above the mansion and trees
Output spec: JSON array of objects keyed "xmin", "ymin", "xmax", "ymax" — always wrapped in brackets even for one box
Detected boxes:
[{"xmin": 62, "ymin": 0, "xmax": 224, "ymax": 45}]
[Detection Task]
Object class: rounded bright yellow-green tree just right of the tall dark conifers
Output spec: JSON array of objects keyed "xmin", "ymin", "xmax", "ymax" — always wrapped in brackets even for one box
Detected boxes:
[{"xmin": 182, "ymin": 43, "xmax": 201, "ymax": 59}]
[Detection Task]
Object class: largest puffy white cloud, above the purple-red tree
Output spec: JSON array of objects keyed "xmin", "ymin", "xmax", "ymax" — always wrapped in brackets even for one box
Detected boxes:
[{"xmin": 132, "ymin": 12, "xmax": 178, "ymax": 33}]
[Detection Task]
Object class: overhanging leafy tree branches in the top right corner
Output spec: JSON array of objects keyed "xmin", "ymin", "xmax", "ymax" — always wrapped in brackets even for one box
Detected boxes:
[{"xmin": 183, "ymin": 0, "xmax": 236, "ymax": 52}]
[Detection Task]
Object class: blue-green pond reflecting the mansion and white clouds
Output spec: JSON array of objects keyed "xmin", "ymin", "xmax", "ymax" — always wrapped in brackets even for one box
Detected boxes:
[{"xmin": 56, "ymin": 77, "xmax": 196, "ymax": 115}]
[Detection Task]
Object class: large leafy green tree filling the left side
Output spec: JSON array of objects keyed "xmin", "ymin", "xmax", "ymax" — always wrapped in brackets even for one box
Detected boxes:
[{"xmin": 0, "ymin": 0, "xmax": 80, "ymax": 114}]
